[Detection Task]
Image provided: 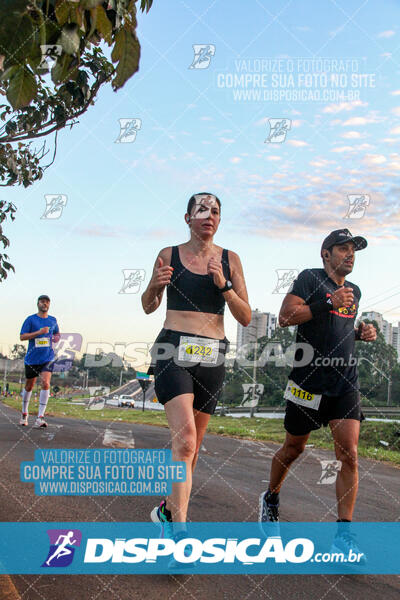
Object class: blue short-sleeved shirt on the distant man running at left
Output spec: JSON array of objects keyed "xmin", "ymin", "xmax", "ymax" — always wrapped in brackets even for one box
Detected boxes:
[{"xmin": 21, "ymin": 315, "xmax": 60, "ymax": 365}]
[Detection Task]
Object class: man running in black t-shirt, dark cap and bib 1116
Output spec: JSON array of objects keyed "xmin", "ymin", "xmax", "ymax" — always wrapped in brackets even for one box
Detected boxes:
[{"xmin": 259, "ymin": 229, "xmax": 376, "ymax": 552}]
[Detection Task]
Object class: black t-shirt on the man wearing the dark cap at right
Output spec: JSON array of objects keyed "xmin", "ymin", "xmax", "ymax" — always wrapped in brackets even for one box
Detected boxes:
[{"xmin": 289, "ymin": 269, "xmax": 361, "ymax": 396}]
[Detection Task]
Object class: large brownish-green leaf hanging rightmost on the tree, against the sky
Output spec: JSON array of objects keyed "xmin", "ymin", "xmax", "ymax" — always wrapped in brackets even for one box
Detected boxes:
[{"xmin": 111, "ymin": 29, "xmax": 140, "ymax": 90}]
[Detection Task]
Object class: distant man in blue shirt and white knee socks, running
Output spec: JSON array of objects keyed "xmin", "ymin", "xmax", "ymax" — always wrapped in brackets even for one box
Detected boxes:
[{"xmin": 19, "ymin": 295, "xmax": 60, "ymax": 428}]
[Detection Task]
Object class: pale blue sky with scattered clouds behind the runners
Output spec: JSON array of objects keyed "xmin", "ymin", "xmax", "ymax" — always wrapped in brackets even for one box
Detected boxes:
[{"xmin": 0, "ymin": 0, "xmax": 400, "ymax": 368}]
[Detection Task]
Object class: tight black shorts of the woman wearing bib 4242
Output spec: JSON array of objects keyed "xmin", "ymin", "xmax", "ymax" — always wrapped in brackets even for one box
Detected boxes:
[{"xmin": 148, "ymin": 329, "xmax": 229, "ymax": 415}]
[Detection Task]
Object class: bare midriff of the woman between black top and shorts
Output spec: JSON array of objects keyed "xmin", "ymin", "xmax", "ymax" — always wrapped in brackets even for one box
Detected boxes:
[{"xmin": 163, "ymin": 310, "xmax": 225, "ymax": 340}]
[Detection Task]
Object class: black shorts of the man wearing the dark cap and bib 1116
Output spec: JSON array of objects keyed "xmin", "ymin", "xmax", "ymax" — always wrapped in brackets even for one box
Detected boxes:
[{"xmin": 284, "ymin": 390, "xmax": 365, "ymax": 435}]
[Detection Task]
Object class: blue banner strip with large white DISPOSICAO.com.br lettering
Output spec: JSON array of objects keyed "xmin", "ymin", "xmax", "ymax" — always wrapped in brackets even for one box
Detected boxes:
[{"xmin": 0, "ymin": 522, "xmax": 400, "ymax": 575}]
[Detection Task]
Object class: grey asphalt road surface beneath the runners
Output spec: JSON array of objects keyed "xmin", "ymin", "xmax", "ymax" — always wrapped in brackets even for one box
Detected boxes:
[{"xmin": 0, "ymin": 404, "xmax": 400, "ymax": 600}]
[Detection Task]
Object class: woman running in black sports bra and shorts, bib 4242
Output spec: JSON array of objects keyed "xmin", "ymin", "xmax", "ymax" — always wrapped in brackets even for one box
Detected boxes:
[{"xmin": 142, "ymin": 193, "xmax": 251, "ymax": 537}]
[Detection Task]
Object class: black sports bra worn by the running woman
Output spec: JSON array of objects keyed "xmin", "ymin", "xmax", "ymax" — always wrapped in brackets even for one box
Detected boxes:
[{"xmin": 167, "ymin": 246, "xmax": 231, "ymax": 315}]
